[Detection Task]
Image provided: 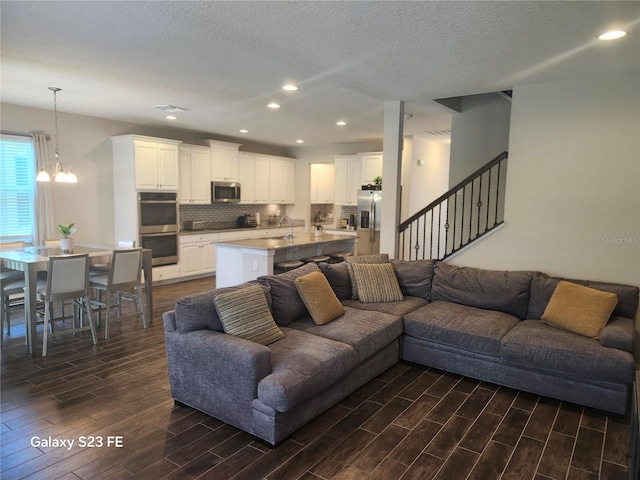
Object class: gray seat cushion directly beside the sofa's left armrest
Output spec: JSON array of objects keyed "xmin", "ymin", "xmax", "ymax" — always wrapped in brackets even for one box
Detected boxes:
[{"xmin": 258, "ymin": 330, "xmax": 358, "ymax": 412}]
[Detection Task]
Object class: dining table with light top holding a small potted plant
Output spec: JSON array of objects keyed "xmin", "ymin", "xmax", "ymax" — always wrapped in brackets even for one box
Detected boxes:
[{"xmin": 0, "ymin": 243, "xmax": 153, "ymax": 355}]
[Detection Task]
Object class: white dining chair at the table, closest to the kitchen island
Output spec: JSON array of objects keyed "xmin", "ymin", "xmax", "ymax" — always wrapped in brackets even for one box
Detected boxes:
[{"xmin": 89, "ymin": 248, "xmax": 147, "ymax": 338}]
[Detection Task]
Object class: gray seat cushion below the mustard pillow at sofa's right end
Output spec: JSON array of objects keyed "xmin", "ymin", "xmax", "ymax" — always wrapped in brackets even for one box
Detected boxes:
[{"xmin": 500, "ymin": 320, "xmax": 635, "ymax": 383}]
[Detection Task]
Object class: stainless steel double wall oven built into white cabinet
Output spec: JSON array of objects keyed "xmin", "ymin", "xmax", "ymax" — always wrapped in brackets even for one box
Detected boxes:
[{"xmin": 138, "ymin": 192, "xmax": 179, "ymax": 266}]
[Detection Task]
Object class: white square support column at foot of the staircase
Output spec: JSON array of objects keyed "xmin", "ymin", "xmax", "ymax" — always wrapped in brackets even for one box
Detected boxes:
[{"xmin": 380, "ymin": 101, "xmax": 404, "ymax": 258}]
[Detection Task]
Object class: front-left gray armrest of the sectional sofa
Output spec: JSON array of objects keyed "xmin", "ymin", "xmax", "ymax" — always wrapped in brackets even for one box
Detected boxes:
[{"xmin": 165, "ymin": 329, "xmax": 271, "ymax": 428}]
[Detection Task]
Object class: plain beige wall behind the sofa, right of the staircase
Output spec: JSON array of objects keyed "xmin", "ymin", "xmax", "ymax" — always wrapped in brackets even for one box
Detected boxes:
[{"xmin": 454, "ymin": 72, "xmax": 640, "ymax": 285}]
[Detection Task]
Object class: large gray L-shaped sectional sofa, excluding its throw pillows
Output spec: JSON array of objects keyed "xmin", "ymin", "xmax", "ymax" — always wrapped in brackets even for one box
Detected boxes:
[{"xmin": 163, "ymin": 260, "xmax": 638, "ymax": 444}]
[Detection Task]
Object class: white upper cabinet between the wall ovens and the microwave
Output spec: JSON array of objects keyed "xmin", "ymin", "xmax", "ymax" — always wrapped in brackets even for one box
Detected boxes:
[{"xmin": 178, "ymin": 144, "xmax": 211, "ymax": 205}]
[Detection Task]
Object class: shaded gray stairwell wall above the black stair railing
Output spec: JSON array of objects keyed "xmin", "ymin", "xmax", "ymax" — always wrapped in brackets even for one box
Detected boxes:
[{"xmin": 449, "ymin": 93, "xmax": 511, "ymax": 187}]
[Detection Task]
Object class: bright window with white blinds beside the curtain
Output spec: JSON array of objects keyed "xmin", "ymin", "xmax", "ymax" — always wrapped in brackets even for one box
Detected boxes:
[{"xmin": 0, "ymin": 135, "xmax": 36, "ymax": 243}]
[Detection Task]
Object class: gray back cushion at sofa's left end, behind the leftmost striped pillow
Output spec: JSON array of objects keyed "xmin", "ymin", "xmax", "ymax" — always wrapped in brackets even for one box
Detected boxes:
[{"xmin": 175, "ymin": 281, "xmax": 271, "ymax": 333}]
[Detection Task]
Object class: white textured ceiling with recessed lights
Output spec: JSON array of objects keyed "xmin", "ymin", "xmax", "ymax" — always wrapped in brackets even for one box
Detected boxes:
[{"xmin": 0, "ymin": 0, "xmax": 640, "ymax": 146}]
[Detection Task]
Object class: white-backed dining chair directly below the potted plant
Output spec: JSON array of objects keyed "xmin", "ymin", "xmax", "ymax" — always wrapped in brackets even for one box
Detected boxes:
[{"xmin": 36, "ymin": 254, "xmax": 97, "ymax": 357}]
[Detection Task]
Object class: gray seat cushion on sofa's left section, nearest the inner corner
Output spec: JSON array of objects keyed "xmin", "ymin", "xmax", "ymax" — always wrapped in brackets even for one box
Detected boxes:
[{"xmin": 289, "ymin": 308, "xmax": 402, "ymax": 362}]
